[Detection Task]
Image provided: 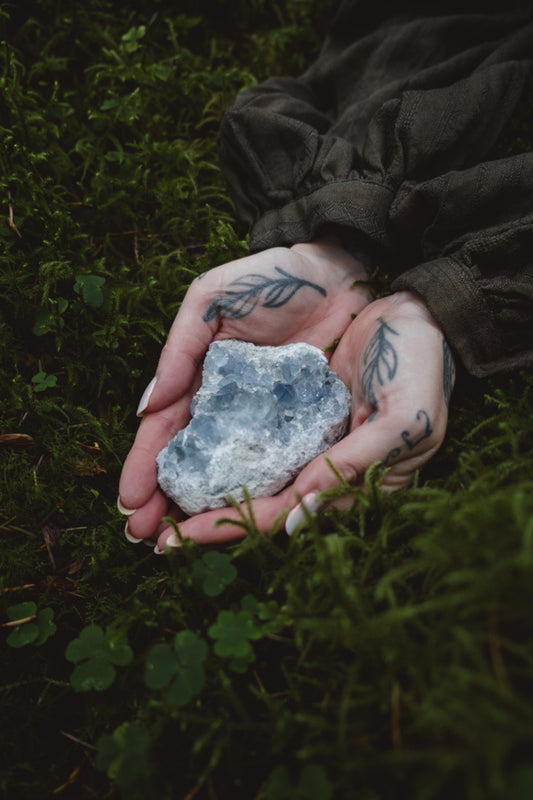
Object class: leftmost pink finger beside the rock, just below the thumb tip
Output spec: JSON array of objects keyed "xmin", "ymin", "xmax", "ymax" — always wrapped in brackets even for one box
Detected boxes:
[{"xmin": 119, "ymin": 391, "xmax": 192, "ymax": 509}]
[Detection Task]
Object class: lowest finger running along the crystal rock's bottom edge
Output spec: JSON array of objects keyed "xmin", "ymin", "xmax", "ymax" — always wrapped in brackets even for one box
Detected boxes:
[{"xmin": 157, "ymin": 482, "xmax": 290, "ymax": 550}]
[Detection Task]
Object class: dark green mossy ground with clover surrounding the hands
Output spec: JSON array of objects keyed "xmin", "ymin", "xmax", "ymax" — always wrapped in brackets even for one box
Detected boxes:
[{"xmin": 0, "ymin": 0, "xmax": 533, "ymax": 800}]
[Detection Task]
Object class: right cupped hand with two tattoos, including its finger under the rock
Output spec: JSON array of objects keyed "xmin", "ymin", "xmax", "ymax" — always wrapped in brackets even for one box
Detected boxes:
[{"xmin": 132, "ymin": 292, "xmax": 454, "ymax": 550}]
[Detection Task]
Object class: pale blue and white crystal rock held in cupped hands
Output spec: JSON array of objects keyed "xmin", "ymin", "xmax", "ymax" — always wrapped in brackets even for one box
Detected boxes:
[{"xmin": 157, "ymin": 339, "xmax": 351, "ymax": 514}]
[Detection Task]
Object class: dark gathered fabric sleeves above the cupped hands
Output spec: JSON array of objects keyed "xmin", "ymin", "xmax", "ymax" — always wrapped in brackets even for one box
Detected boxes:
[{"xmin": 219, "ymin": 0, "xmax": 533, "ymax": 376}]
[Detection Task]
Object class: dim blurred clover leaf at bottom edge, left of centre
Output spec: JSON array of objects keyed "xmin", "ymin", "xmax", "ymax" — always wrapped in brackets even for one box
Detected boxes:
[{"xmin": 95, "ymin": 722, "xmax": 148, "ymax": 800}]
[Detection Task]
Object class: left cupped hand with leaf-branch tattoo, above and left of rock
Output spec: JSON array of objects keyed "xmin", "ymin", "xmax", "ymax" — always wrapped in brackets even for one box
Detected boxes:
[{"xmin": 119, "ymin": 237, "xmax": 371, "ymax": 548}]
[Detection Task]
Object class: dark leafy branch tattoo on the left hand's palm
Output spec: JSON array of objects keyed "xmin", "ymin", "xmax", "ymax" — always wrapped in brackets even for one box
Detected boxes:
[{"xmin": 202, "ymin": 267, "xmax": 327, "ymax": 322}]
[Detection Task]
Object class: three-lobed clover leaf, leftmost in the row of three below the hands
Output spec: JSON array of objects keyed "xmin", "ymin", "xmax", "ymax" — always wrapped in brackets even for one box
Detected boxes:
[{"xmin": 65, "ymin": 625, "xmax": 133, "ymax": 692}]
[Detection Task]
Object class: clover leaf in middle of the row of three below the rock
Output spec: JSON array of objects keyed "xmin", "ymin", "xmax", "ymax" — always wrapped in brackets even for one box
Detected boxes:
[{"xmin": 145, "ymin": 631, "xmax": 207, "ymax": 706}]
